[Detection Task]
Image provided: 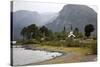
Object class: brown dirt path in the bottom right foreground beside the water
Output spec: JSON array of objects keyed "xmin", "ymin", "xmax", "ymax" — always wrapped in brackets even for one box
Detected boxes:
[{"xmin": 25, "ymin": 52, "xmax": 97, "ymax": 65}]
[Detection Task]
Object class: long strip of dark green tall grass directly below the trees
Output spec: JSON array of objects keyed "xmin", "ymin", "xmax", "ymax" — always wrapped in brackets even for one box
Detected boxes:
[{"xmin": 18, "ymin": 38, "xmax": 97, "ymax": 54}]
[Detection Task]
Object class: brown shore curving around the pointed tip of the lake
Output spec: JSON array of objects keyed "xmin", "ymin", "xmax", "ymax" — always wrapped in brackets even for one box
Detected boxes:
[{"xmin": 12, "ymin": 46, "xmax": 97, "ymax": 66}]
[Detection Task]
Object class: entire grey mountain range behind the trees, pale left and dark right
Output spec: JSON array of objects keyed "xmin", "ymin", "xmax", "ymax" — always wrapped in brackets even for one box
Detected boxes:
[{"xmin": 12, "ymin": 4, "xmax": 97, "ymax": 40}]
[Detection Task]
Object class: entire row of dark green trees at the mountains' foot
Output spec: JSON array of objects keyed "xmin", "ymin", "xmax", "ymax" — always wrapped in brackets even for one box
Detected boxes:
[{"xmin": 21, "ymin": 24, "xmax": 94, "ymax": 40}]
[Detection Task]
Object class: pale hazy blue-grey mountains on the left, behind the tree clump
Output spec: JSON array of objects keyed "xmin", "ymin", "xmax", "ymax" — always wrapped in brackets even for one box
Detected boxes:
[{"xmin": 12, "ymin": 10, "xmax": 57, "ymax": 40}]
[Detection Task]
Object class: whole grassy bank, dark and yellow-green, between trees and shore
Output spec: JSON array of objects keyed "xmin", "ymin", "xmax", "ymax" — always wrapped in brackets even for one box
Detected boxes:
[{"xmin": 17, "ymin": 38, "xmax": 97, "ymax": 54}]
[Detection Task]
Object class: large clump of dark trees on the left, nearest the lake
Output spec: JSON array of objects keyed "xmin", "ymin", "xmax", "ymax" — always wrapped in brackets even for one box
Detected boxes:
[{"xmin": 21, "ymin": 24, "xmax": 52, "ymax": 40}]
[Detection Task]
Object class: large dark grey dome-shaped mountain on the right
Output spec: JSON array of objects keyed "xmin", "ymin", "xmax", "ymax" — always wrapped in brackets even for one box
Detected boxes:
[{"xmin": 46, "ymin": 4, "xmax": 97, "ymax": 33}]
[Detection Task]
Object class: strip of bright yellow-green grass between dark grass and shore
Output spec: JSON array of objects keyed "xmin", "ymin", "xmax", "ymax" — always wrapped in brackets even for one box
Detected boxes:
[{"xmin": 33, "ymin": 46, "xmax": 91, "ymax": 55}]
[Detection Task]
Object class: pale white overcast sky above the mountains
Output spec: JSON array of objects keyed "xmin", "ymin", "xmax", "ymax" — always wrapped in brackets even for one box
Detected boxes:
[{"xmin": 13, "ymin": 1, "xmax": 97, "ymax": 13}]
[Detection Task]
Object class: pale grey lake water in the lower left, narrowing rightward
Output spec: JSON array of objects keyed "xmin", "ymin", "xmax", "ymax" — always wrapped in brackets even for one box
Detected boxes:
[{"xmin": 13, "ymin": 47, "xmax": 62, "ymax": 65}]
